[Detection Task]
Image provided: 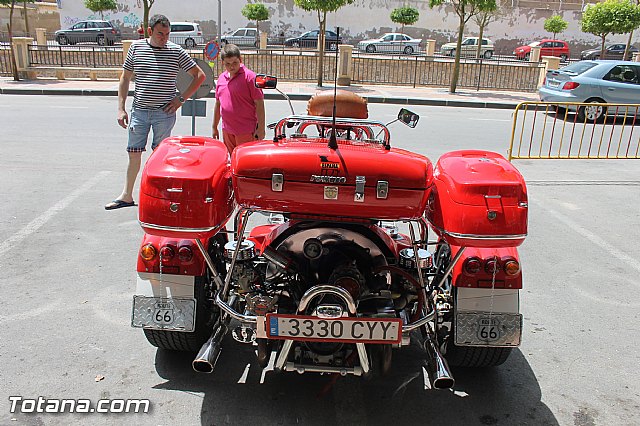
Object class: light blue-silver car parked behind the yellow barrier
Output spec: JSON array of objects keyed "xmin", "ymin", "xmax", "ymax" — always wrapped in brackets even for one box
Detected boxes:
[{"xmin": 538, "ymin": 60, "xmax": 640, "ymax": 122}]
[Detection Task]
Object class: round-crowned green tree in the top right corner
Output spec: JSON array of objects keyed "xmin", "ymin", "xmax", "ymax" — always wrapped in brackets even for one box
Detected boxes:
[{"xmin": 580, "ymin": 0, "xmax": 640, "ymax": 58}]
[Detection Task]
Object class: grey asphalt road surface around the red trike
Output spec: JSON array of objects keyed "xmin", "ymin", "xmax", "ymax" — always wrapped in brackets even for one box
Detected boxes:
[{"xmin": 0, "ymin": 95, "xmax": 640, "ymax": 426}]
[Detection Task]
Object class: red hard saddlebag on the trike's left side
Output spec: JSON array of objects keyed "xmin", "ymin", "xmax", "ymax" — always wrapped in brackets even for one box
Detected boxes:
[{"xmin": 139, "ymin": 136, "xmax": 235, "ymax": 238}]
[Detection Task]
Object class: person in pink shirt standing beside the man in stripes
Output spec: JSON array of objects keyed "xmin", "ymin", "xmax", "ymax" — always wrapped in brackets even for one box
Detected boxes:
[{"xmin": 213, "ymin": 44, "xmax": 265, "ymax": 154}]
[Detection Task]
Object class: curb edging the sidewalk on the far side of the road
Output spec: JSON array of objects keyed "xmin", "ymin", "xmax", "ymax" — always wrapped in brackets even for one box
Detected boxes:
[{"xmin": 0, "ymin": 87, "xmax": 518, "ymax": 109}]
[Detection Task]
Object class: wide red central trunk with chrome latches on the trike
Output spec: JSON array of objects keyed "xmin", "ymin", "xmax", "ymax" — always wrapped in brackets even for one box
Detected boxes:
[{"xmin": 231, "ymin": 139, "xmax": 433, "ymax": 220}]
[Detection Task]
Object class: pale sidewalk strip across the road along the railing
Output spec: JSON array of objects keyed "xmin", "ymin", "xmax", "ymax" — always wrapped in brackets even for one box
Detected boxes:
[{"xmin": 0, "ymin": 77, "xmax": 539, "ymax": 109}]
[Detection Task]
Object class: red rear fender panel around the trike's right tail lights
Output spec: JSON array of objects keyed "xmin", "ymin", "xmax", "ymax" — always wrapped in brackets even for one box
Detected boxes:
[{"xmin": 451, "ymin": 245, "xmax": 522, "ymax": 289}]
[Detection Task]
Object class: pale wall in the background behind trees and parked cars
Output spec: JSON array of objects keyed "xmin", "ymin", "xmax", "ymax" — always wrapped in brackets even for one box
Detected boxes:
[{"xmin": 60, "ymin": 0, "xmax": 640, "ymax": 56}]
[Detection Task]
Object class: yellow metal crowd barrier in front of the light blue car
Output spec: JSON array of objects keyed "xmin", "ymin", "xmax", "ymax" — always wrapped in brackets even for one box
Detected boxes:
[{"xmin": 508, "ymin": 102, "xmax": 640, "ymax": 161}]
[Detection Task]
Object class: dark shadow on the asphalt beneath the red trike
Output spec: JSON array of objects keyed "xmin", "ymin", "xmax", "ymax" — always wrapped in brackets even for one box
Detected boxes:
[{"xmin": 154, "ymin": 338, "xmax": 558, "ymax": 425}]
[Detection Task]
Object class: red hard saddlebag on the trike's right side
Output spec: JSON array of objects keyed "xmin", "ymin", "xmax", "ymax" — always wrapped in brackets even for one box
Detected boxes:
[{"xmin": 427, "ymin": 150, "xmax": 528, "ymax": 247}]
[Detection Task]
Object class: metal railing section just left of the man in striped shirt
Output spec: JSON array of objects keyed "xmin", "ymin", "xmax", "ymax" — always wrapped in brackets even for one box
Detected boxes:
[{"xmin": 28, "ymin": 45, "xmax": 122, "ymax": 68}]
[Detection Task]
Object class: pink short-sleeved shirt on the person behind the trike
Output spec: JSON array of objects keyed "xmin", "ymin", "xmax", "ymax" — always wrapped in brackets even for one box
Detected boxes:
[{"xmin": 216, "ymin": 64, "xmax": 264, "ymax": 135}]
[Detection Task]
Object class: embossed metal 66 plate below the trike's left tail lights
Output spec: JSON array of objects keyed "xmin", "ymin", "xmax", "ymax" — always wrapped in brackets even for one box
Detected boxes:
[{"xmin": 131, "ymin": 296, "xmax": 196, "ymax": 331}]
